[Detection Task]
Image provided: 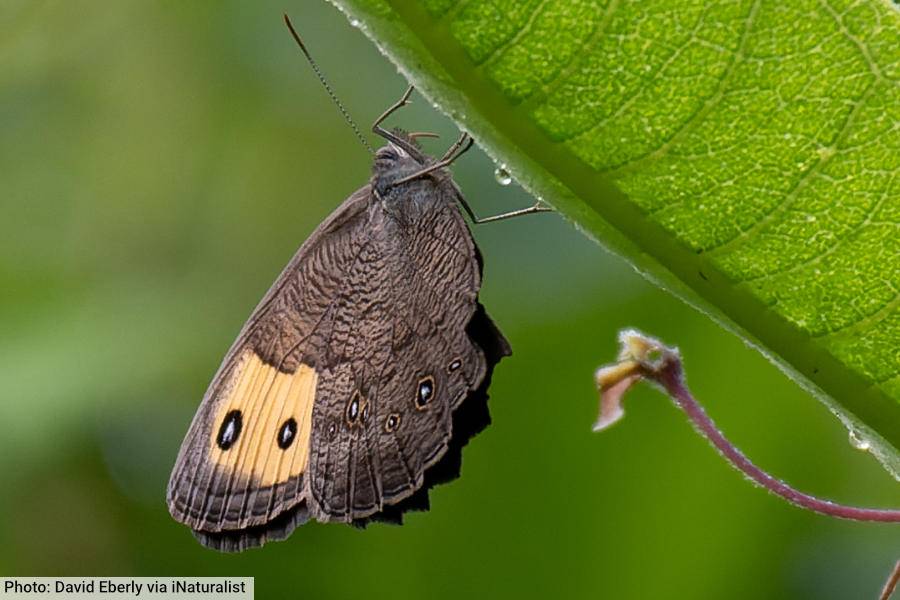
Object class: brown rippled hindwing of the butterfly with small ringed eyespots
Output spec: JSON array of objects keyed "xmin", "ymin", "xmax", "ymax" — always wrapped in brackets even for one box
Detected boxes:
[{"xmin": 309, "ymin": 180, "xmax": 485, "ymax": 521}]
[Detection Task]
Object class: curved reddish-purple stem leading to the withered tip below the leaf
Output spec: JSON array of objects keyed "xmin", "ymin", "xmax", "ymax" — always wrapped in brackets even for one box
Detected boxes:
[{"xmin": 650, "ymin": 361, "xmax": 900, "ymax": 524}]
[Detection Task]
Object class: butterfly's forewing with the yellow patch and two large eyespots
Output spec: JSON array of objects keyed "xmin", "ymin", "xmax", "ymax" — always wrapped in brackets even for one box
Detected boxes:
[{"xmin": 168, "ymin": 187, "xmax": 370, "ymax": 531}]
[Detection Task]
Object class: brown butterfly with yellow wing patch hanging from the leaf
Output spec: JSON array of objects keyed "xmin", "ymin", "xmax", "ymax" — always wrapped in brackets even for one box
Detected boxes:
[{"xmin": 168, "ymin": 22, "xmax": 546, "ymax": 550}]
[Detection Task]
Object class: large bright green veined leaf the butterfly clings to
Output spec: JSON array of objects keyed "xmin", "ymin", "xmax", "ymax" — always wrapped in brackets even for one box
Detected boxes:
[{"xmin": 334, "ymin": 0, "xmax": 900, "ymax": 476}]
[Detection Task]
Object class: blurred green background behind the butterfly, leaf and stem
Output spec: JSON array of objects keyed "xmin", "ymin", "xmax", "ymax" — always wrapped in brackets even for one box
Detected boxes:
[{"xmin": 0, "ymin": 0, "xmax": 900, "ymax": 599}]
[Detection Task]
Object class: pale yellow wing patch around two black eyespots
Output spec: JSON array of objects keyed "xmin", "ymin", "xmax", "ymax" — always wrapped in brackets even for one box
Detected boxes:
[{"xmin": 210, "ymin": 350, "xmax": 318, "ymax": 487}]
